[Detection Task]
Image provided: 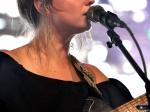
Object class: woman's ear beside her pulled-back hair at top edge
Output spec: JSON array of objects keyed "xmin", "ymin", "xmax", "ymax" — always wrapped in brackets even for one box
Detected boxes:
[{"xmin": 34, "ymin": 0, "xmax": 50, "ymax": 13}]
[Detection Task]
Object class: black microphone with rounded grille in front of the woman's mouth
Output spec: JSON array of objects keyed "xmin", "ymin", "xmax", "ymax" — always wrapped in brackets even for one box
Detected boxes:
[{"xmin": 87, "ymin": 5, "xmax": 126, "ymax": 30}]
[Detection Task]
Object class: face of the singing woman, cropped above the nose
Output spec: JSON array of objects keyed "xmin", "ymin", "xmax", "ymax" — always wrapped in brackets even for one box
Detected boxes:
[{"xmin": 50, "ymin": 0, "xmax": 94, "ymax": 35}]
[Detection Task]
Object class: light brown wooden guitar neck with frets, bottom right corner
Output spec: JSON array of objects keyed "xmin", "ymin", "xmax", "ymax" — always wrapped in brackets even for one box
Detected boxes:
[{"xmin": 111, "ymin": 94, "xmax": 148, "ymax": 112}]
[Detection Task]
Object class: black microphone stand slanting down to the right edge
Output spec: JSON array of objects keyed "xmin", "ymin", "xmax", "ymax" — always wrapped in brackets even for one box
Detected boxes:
[{"xmin": 107, "ymin": 30, "xmax": 150, "ymax": 111}]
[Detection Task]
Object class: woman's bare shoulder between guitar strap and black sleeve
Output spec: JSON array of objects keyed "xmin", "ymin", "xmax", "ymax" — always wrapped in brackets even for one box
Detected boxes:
[{"xmin": 83, "ymin": 63, "xmax": 109, "ymax": 84}]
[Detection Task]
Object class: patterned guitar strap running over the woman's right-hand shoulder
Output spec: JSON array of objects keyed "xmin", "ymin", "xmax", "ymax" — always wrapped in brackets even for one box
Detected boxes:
[{"xmin": 71, "ymin": 55, "xmax": 109, "ymax": 105}]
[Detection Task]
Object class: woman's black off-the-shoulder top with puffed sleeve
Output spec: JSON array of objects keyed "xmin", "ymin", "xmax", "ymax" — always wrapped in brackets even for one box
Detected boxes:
[{"xmin": 0, "ymin": 52, "xmax": 132, "ymax": 112}]
